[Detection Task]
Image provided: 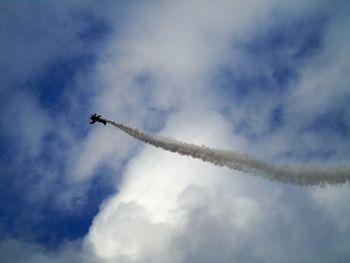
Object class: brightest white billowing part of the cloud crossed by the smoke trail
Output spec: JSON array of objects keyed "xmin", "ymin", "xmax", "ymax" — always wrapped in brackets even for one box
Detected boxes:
[{"xmin": 88, "ymin": 111, "xmax": 249, "ymax": 262}]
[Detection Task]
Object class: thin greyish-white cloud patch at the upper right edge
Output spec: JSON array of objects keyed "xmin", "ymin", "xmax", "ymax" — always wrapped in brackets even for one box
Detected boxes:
[{"xmin": 290, "ymin": 4, "xmax": 350, "ymax": 119}]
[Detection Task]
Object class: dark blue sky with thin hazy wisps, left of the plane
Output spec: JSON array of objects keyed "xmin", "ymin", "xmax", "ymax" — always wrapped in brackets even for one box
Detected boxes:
[{"xmin": 0, "ymin": 1, "xmax": 121, "ymax": 246}]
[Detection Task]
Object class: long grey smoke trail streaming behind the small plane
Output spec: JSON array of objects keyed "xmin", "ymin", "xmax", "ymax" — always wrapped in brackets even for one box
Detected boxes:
[{"xmin": 106, "ymin": 120, "xmax": 350, "ymax": 185}]
